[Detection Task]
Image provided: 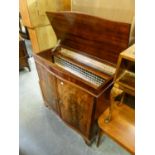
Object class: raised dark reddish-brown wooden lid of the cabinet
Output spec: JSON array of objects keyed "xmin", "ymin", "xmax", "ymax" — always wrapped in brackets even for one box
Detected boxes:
[{"xmin": 46, "ymin": 11, "xmax": 130, "ymax": 64}]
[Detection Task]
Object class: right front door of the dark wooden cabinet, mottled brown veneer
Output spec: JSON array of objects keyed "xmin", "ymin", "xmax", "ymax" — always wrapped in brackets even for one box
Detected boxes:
[{"xmin": 57, "ymin": 79, "xmax": 94, "ymax": 137}]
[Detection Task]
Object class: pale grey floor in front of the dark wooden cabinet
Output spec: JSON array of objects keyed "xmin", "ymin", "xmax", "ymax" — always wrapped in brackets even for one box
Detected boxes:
[{"xmin": 19, "ymin": 40, "xmax": 129, "ymax": 155}]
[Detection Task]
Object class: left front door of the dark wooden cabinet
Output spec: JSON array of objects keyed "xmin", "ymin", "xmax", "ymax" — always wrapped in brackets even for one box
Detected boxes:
[{"xmin": 36, "ymin": 63, "xmax": 59, "ymax": 113}]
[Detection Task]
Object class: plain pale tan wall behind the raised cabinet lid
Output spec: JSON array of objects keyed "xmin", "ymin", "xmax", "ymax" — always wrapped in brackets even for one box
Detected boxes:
[{"xmin": 72, "ymin": 0, "xmax": 135, "ymax": 23}]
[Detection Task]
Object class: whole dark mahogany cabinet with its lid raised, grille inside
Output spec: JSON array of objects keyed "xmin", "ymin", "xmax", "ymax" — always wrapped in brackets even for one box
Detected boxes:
[{"xmin": 34, "ymin": 12, "xmax": 130, "ymax": 142}]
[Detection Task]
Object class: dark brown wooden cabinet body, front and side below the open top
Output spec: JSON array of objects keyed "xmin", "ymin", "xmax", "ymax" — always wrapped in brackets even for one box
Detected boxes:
[{"xmin": 34, "ymin": 58, "xmax": 109, "ymax": 143}]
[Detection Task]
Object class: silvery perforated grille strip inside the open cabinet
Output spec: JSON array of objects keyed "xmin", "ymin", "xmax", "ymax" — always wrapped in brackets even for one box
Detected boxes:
[{"xmin": 54, "ymin": 57, "xmax": 105, "ymax": 86}]
